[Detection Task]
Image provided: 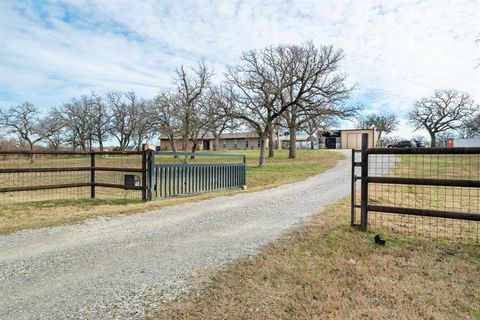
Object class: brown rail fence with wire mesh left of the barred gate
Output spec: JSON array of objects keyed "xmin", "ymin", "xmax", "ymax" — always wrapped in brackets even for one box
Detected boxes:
[{"xmin": 0, "ymin": 150, "xmax": 146, "ymax": 204}]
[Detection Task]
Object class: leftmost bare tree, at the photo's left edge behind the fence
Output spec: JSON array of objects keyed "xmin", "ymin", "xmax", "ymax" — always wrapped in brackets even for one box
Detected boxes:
[{"xmin": 0, "ymin": 102, "xmax": 43, "ymax": 162}]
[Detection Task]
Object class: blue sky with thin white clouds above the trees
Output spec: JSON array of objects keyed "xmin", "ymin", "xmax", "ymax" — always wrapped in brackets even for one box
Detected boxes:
[{"xmin": 0, "ymin": 0, "xmax": 480, "ymax": 137}]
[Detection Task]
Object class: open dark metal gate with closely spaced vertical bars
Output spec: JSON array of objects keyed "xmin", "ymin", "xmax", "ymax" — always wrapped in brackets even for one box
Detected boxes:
[{"xmin": 148, "ymin": 152, "xmax": 246, "ymax": 199}]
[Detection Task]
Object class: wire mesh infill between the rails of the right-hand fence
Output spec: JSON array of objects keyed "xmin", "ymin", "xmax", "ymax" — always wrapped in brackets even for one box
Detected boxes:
[{"xmin": 368, "ymin": 153, "xmax": 480, "ymax": 242}]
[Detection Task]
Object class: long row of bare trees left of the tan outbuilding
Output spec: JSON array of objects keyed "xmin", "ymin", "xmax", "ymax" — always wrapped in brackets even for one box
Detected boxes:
[{"xmin": 0, "ymin": 42, "xmax": 360, "ymax": 166}]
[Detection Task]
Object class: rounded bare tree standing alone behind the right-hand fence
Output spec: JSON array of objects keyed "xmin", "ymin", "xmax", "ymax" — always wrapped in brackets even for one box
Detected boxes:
[{"xmin": 409, "ymin": 89, "xmax": 478, "ymax": 147}]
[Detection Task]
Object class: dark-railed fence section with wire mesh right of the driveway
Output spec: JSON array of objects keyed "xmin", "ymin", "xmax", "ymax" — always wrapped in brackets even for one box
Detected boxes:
[{"xmin": 352, "ymin": 134, "xmax": 480, "ymax": 242}]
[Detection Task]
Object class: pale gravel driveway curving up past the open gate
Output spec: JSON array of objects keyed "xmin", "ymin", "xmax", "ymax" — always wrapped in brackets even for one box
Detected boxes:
[{"xmin": 0, "ymin": 151, "xmax": 351, "ymax": 319}]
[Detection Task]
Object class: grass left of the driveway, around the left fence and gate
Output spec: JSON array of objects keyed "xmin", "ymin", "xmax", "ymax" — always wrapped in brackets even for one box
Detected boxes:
[{"xmin": 0, "ymin": 150, "xmax": 344, "ymax": 234}]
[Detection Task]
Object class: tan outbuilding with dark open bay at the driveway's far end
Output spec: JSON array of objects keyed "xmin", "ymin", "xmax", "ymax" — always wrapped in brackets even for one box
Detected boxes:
[{"xmin": 320, "ymin": 129, "xmax": 378, "ymax": 149}]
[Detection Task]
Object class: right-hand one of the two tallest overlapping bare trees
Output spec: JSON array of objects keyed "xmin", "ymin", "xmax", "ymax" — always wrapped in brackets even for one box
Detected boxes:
[{"xmin": 279, "ymin": 42, "xmax": 357, "ymax": 158}]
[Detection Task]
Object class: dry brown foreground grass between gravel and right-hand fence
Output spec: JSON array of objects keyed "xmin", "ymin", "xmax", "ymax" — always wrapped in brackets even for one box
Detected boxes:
[{"xmin": 152, "ymin": 200, "xmax": 480, "ymax": 319}]
